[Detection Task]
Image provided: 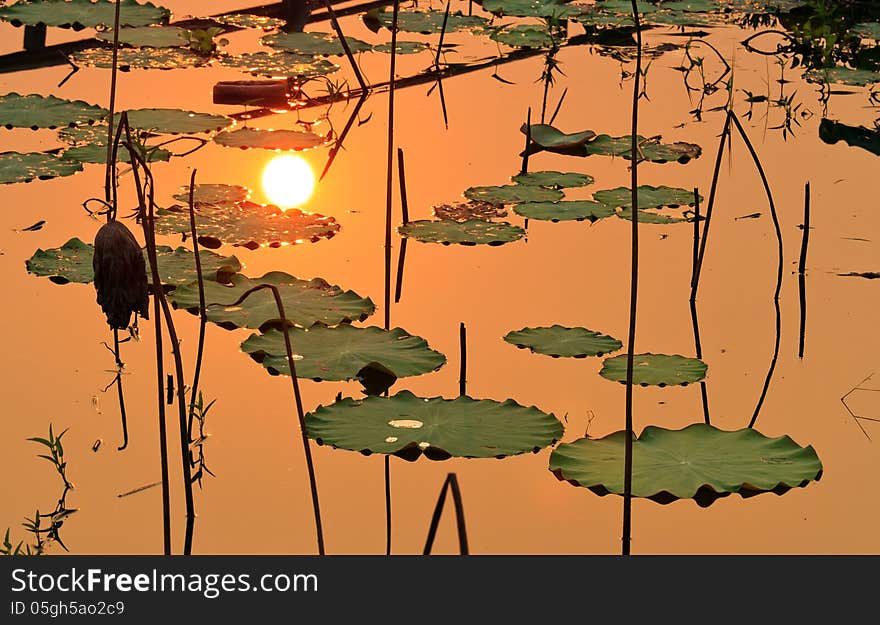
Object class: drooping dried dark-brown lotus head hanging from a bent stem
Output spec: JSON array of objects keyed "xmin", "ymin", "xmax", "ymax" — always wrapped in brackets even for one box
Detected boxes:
[{"xmin": 92, "ymin": 220, "xmax": 150, "ymax": 330}]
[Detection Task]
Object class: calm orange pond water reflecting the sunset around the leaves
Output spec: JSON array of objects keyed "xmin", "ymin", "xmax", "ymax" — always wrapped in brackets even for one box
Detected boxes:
[{"xmin": 0, "ymin": 1, "xmax": 880, "ymax": 554}]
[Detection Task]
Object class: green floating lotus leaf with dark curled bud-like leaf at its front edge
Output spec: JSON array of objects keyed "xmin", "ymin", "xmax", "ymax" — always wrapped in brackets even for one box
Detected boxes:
[{"xmin": 241, "ymin": 324, "xmax": 446, "ymax": 381}]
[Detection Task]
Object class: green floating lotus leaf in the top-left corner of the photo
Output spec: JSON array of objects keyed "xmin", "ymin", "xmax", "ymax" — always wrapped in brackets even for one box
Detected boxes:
[{"xmin": 0, "ymin": 0, "xmax": 171, "ymax": 30}]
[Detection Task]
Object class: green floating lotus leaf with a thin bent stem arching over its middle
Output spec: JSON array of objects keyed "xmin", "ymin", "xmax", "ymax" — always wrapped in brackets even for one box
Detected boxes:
[{"xmin": 170, "ymin": 271, "xmax": 376, "ymax": 330}]
